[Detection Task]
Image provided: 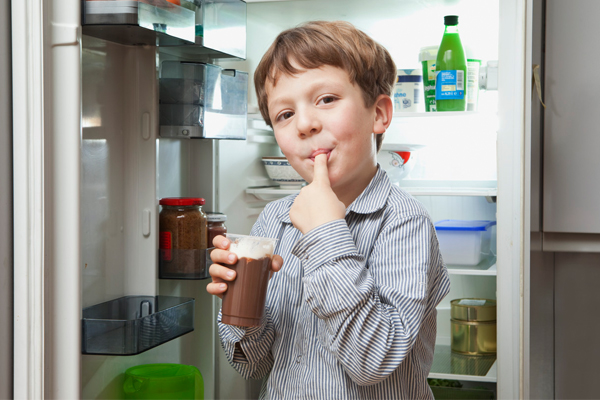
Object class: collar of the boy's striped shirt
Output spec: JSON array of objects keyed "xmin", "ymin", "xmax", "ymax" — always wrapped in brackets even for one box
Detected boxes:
[{"xmin": 279, "ymin": 164, "xmax": 392, "ymax": 223}]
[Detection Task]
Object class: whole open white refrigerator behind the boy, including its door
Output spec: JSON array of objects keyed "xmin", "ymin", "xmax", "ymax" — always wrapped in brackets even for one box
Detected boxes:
[{"xmin": 5, "ymin": 0, "xmax": 533, "ymax": 399}]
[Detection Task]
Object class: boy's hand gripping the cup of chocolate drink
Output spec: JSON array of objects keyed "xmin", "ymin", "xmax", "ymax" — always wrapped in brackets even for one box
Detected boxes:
[{"xmin": 206, "ymin": 235, "xmax": 283, "ymax": 298}]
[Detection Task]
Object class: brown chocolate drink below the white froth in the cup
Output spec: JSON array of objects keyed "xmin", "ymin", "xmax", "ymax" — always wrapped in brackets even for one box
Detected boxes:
[{"xmin": 221, "ymin": 257, "xmax": 271, "ymax": 326}]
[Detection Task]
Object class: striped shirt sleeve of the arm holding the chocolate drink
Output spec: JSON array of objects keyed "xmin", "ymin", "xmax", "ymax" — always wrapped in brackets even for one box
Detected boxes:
[{"xmin": 217, "ymin": 208, "xmax": 275, "ymax": 379}]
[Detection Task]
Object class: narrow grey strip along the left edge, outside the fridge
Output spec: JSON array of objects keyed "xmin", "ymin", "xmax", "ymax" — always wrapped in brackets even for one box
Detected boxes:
[{"xmin": 0, "ymin": 2, "xmax": 13, "ymax": 399}]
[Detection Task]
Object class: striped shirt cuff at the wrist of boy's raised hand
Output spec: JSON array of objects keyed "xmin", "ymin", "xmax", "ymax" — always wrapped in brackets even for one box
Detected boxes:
[{"xmin": 292, "ymin": 219, "xmax": 360, "ymax": 275}]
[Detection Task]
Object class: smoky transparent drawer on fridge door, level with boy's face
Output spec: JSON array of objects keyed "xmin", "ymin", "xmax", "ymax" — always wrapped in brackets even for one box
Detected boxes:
[{"xmin": 159, "ymin": 61, "xmax": 248, "ymax": 139}]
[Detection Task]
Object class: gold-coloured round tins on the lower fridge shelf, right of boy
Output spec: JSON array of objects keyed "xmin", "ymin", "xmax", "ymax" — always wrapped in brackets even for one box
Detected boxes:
[{"xmin": 450, "ymin": 299, "xmax": 496, "ymax": 355}]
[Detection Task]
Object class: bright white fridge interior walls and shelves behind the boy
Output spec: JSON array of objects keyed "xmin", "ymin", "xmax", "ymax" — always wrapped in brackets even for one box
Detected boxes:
[{"xmin": 219, "ymin": 0, "xmax": 501, "ymax": 398}]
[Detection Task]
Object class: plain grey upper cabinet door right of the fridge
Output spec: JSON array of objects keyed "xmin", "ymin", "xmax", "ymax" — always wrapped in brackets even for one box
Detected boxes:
[{"xmin": 543, "ymin": 0, "xmax": 600, "ymax": 233}]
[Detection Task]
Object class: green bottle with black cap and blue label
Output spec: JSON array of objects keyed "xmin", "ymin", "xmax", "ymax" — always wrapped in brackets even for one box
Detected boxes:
[{"xmin": 435, "ymin": 15, "xmax": 467, "ymax": 111}]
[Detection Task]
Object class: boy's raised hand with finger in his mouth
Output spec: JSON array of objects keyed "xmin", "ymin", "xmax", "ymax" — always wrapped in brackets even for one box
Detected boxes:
[{"xmin": 290, "ymin": 154, "xmax": 346, "ymax": 234}]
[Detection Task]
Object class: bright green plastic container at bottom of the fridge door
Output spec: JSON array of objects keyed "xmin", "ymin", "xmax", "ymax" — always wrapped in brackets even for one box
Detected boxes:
[{"xmin": 123, "ymin": 364, "xmax": 204, "ymax": 399}]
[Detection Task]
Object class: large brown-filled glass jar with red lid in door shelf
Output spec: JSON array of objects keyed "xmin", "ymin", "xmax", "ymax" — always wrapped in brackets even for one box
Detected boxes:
[{"xmin": 159, "ymin": 197, "xmax": 207, "ymax": 279}]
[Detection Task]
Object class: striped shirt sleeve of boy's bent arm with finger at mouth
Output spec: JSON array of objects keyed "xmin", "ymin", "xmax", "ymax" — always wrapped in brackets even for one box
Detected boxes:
[{"xmin": 292, "ymin": 215, "xmax": 442, "ymax": 385}]
